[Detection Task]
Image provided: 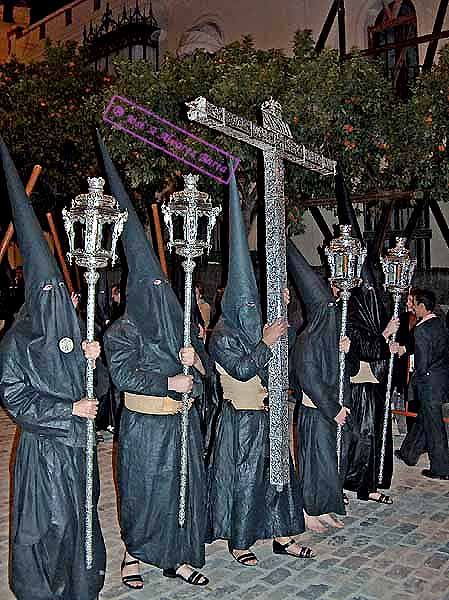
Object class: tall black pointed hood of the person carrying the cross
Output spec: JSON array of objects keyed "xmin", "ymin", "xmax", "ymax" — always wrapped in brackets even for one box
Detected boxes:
[{"xmin": 221, "ymin": 169, "xmax": 262, "ymax": 345}]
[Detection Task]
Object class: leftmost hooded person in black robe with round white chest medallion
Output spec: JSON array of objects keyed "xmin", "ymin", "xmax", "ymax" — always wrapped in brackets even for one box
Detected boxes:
[{"xmin": 0, "ymin": 142, "xmax": 105, "ymax": 600}]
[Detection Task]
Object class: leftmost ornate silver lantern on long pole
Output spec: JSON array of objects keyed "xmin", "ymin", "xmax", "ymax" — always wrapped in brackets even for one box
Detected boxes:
[{"xmin": 62, "ymin": 177, "xmax": 128, "ymax": 569}]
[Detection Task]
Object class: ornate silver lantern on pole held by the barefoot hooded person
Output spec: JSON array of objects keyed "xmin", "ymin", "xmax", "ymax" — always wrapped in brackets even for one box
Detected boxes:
[{"xmin": 325, "ymin": 225, "xmax": 366, "ymax": 469}]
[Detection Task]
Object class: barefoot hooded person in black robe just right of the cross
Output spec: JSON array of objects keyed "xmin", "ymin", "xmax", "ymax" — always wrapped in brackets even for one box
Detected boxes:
[{"xmin": 287, "ymin": 241, "xmax": 354, "ymax": 531}]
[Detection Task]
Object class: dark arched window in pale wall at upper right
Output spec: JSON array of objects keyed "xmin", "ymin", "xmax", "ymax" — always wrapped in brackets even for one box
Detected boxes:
[{"xmin": 368, "ymin": 0, "xmax": 419, "ymax": 98}]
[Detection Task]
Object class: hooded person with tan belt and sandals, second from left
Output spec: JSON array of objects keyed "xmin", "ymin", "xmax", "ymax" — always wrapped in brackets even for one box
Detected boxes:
[{"xmin": 99, "ymin": 135, "xmax": 208, "ymax": 589}]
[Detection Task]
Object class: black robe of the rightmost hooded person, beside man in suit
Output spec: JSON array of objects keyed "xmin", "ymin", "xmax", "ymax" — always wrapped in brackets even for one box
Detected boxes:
[{"xmin": 345, "ymin": 320, "xmax": 393, "ymax": 500}]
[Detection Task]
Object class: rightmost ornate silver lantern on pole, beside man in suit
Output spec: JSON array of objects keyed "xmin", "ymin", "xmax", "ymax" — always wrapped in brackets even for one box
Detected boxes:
[{"xmin": 378, "ymin": 237, "xmax": 416, "ymax": 483}]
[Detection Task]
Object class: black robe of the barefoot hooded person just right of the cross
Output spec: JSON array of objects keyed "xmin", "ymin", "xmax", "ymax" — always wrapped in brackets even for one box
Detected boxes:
[{"xmin": 290, "ymin": 301, "xmax": 358, "ymax": 516}]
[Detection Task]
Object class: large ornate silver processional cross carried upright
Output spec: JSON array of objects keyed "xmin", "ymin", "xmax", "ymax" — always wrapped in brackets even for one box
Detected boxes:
[{"xmin": 186, "ymin": 97, "xmax": 336, "ymax": 488}]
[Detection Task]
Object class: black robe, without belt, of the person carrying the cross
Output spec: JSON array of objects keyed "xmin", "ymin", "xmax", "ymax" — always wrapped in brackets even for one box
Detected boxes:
[{"xmin": 207, "ymin": 322, "xmax": 304, "ymax": 550}]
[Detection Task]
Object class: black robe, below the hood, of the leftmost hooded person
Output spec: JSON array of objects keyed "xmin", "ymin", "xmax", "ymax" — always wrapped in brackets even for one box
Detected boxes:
[{"xmin": 0, "ymin": 318, "xmax": 106, "ymax": 600}]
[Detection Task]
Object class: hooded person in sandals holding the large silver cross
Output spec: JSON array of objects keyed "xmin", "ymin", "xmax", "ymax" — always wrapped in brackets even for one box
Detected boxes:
[{"xmin": 207, "ymin": 177, "xmax": 312, "ymax": 566}]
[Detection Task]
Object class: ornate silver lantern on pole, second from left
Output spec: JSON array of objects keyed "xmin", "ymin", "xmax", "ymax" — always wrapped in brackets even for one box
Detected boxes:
[{"xmin": 162, "ymin": 174, "xmax": 221, "ymax": 527}]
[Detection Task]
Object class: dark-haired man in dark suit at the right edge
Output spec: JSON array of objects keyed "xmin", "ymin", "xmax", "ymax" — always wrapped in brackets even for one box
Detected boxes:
[{"xmin": 390, "ymin": 290, "xmax": 449, "ymax": 480}]
